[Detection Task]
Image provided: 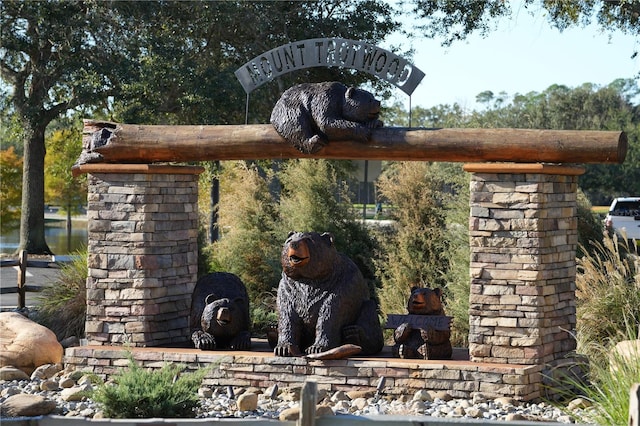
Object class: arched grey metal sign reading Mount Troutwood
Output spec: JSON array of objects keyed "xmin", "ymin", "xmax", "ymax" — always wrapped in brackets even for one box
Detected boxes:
[{"xmin": 235, "ymin": 38, "xmax": 424, "ymax": 96}]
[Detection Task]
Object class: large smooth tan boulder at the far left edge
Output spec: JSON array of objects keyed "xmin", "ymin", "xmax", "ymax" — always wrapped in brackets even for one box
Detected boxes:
[{"xmin": 0, "ymin": 312, "xmax": 64, "ymax": 374}]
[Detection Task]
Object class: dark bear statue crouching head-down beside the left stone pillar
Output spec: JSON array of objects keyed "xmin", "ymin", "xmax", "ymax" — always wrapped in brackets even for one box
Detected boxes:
[{"xmin": 189, "ymin": 272, "xmax": 251, "ymax": 350}]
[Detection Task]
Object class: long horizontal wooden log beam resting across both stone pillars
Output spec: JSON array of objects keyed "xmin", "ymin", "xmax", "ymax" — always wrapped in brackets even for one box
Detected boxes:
[{"xmin": 76, "ymin": 120, "xmax": 627, "ymax": 166}]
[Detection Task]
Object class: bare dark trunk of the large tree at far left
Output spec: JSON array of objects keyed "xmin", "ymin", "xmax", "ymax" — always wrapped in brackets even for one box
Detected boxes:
[{"xmin": 17, "ymin": 124, "xmax": 52, "ymax": 254}]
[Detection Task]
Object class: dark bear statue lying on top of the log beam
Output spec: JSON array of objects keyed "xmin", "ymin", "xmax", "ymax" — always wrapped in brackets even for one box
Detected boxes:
[{"xmin": 271, "ymin": 82, "xmax": 383, "ymax": 154}]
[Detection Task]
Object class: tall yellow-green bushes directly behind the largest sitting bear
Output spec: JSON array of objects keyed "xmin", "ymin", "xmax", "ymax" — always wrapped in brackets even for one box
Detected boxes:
[{"xmin": 205, "ymin": 159, "xmax": 375, "ymax": 329}]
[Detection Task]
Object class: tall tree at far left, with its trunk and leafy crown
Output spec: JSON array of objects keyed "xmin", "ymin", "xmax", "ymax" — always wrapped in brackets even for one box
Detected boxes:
[{"xmin": 0, "ymin": 0, "xmax": 125, "ymax": 254}]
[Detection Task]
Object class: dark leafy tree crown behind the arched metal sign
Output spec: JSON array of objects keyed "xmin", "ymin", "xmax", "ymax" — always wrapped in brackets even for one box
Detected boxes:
[{"xmin": 113, "ymin": 0, "xmax": 400, "ymax": 124}]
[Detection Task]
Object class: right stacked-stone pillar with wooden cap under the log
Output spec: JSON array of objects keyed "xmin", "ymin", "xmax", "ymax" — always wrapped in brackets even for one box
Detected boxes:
[{"xmin": 465, "ymin": 164, "xmax": 584, "ymax": 366}]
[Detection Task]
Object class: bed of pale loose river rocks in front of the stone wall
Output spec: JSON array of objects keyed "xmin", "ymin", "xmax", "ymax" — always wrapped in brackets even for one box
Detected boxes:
[{"xmin": 0, "ymin": 362, "xmax": 588, "ymax": 423}]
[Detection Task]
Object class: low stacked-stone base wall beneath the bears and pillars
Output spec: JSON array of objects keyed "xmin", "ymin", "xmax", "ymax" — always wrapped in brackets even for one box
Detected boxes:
[{"xmin": 64, "ymin": 347, "xmax": 543, "ymax": 401}]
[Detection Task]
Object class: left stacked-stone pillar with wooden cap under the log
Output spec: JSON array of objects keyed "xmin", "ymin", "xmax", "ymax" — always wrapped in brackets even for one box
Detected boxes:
[{"xmin": 80, "ymin": 164, "xmax": 203, "ymax": 346}]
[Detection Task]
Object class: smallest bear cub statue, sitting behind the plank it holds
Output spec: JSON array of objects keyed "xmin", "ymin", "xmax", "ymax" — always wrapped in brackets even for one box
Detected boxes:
[{"xmin": 391, "ymin": 287, "xmax": 453, "ymax": 359}]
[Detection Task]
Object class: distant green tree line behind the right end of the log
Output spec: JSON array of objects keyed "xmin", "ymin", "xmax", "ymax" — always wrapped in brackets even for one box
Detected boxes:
[{"xmin": 384, "ymin": 79, "xmax": 640, "ymax": 205}]
